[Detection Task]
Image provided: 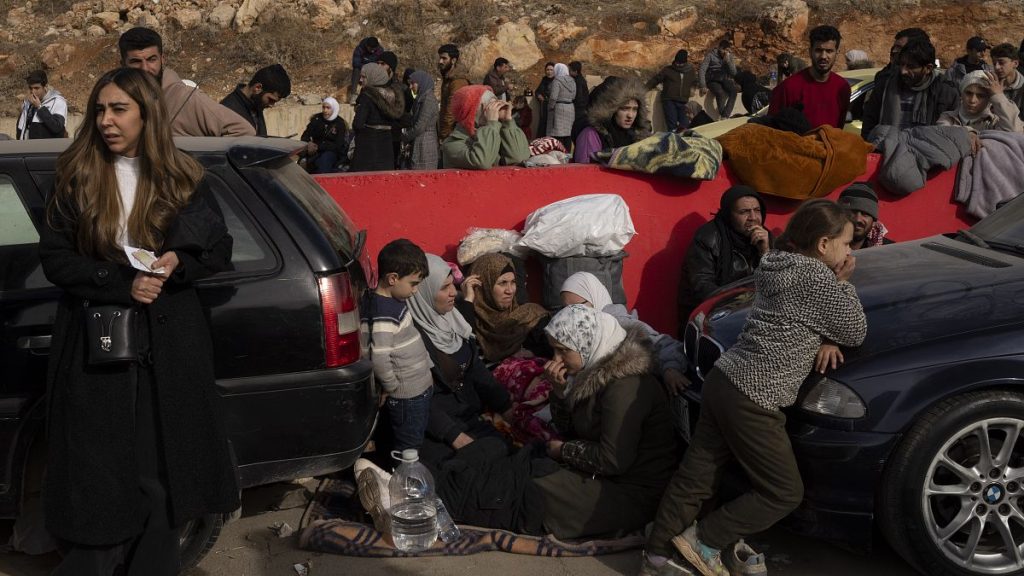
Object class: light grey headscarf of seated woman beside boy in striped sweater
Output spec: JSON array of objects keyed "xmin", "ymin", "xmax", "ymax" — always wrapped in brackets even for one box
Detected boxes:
[{"xmin": 409, "ymin": 254, "xmax": 473, "ymax": 354}]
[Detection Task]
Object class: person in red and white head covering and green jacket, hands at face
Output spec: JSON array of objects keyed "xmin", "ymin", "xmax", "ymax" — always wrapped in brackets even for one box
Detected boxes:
[{"xmin": 441, "ymin": 84, "xmax": 529, "ymax": 170}]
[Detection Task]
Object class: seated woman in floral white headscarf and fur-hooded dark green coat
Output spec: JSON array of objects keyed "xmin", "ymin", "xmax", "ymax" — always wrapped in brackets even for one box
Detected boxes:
[{"xmin": 534, "ymin": 304, "xmax": 676, "ymax": 538}]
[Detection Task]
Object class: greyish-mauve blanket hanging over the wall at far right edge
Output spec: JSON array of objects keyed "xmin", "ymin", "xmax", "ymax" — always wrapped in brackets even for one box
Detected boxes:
[{"xmin": 955, "ymin": 130, "xmax": 1024, "ymax": 218}]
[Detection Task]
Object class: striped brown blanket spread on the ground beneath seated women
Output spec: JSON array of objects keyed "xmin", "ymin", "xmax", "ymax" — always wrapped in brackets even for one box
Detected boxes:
[{"xmin": 299, "ymin": 479, "xmax": 643, "ymax": 558}]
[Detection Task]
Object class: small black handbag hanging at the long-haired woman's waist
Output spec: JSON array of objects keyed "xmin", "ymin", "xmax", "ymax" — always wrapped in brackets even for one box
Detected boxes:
[{"xmin": 85, "ymin": 302, "xmax": 138, "ymax": 366}]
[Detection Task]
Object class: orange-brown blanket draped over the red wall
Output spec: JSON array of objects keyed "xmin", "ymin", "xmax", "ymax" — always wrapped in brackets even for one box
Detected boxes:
[{"xmin": 718, "ymin": 123, "xmax": 872, "ymax": 200}]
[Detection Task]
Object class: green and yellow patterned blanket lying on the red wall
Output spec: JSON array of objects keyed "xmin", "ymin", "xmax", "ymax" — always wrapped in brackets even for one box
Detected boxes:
[{"xmin": 595, "ymin": 132, "xmax": 722, "ymax": 180}]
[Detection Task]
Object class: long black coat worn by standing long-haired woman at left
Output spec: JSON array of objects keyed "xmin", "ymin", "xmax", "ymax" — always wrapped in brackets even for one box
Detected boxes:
[{"xmin": 39, "ymin": 181, "xmax": 239, "ymax": 545}]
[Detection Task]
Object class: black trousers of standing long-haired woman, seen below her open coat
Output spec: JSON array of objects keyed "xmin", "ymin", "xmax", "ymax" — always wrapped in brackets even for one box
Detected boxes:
[{"xmin": 52, "ymin": 364, "xmax": 180, "ymax": 576}]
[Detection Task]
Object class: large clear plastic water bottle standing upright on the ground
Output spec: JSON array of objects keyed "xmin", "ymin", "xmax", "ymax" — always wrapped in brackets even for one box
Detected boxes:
[{"xmin": 388, "ymin": 448, "xmax": 438, "ymax": 552}]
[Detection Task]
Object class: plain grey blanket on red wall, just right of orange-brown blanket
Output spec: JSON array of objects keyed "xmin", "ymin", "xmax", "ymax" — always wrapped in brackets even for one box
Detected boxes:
[{"xmin": 868, "ymin": 125, "xmax": 971, "ymax": 196}]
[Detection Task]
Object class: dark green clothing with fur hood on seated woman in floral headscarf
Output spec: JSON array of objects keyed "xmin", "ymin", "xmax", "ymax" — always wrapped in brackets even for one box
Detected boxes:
[{"xmin": 534, "ymin": 329, "xmax": 677, "ymax": 538}]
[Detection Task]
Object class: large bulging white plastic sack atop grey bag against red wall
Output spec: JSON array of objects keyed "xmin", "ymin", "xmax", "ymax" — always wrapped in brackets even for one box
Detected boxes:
[{"xmin": 516, "ymin": 194, "xmax": 636, "ymax": 258}]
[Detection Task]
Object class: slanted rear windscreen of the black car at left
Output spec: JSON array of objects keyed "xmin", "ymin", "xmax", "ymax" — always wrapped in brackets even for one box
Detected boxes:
[{"xmin": 271, "ymin": 157, "xmax": 358, "ymax": 257}]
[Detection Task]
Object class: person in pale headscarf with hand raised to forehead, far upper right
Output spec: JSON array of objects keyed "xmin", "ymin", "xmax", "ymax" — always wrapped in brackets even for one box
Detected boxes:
[{"xmin": 937, "ymin": 70, "xmax": 1024, "ymax": 132}]
